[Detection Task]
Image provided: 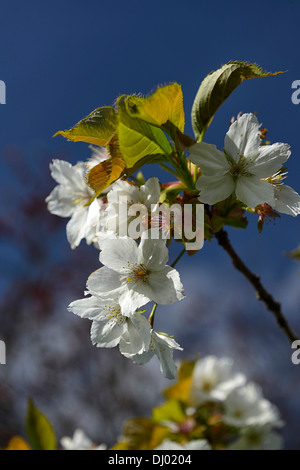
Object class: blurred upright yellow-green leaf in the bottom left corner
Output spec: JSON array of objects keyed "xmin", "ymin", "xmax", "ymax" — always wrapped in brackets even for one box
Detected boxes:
[{"xmin": 26, "ymin": 400, "xmax": 57, "ymax": 450}]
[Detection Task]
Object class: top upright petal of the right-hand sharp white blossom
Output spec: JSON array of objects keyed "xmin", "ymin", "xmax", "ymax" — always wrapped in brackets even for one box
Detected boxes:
[{"xmin": 224, "ymin": 113, "xmax": 261, "ymax": 162}]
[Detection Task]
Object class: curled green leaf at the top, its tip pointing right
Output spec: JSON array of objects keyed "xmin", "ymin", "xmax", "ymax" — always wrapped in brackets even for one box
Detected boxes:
[{"xmin": 192, "ymin": 61, "xmax": 283, "ymax": 140}]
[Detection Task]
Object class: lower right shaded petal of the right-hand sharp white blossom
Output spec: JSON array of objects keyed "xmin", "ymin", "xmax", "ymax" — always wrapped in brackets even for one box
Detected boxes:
[{"xmin": 235, "ymin": 176, "xmax": 274, "ymax": 208}]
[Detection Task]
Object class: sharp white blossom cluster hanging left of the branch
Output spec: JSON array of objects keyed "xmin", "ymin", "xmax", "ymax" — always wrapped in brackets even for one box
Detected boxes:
[{"xmin": 46, "ymin": 153, "xmax": 184, "ymax": 379}]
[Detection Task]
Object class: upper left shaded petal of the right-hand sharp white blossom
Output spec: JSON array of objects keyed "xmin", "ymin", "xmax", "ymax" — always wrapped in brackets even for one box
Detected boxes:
[{"xmin": 189, "ymin": 142, "xmax": 230, "ymax": 175}]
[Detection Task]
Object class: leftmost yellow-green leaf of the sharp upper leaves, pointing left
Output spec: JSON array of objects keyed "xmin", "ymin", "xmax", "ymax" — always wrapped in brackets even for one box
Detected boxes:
[{"xmin": 53, "ymin": 106, "xmax": 118, "ymax": 146}]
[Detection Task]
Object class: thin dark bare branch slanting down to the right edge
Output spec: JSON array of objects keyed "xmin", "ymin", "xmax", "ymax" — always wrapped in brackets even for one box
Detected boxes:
[{"xmin": 215, "ymin": 229, "xmax": 298, "ymax": 342}]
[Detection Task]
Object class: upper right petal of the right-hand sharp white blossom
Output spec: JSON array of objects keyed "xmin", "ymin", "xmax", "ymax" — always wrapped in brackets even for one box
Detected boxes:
[{"xmin": 247, "ymin": 143, "xmax": 291, "ymax": 178}]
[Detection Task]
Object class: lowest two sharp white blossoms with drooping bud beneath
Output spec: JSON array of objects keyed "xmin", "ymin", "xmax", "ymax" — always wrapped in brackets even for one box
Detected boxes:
[{"xmin": 69, "ymin": 232, "xmax": 184, "ymax": 378}]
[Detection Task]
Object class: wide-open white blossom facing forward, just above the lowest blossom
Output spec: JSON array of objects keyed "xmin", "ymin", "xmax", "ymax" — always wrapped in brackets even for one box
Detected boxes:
[{"xmin": 88, "ymin": 232, "xmax": 184, "ymax": 315}]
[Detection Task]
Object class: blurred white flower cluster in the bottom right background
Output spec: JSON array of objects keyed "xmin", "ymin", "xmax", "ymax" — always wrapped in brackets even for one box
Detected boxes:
[{"xmin": 190, "ymin": 356, "xmax": 284, "ymax": 450}]
